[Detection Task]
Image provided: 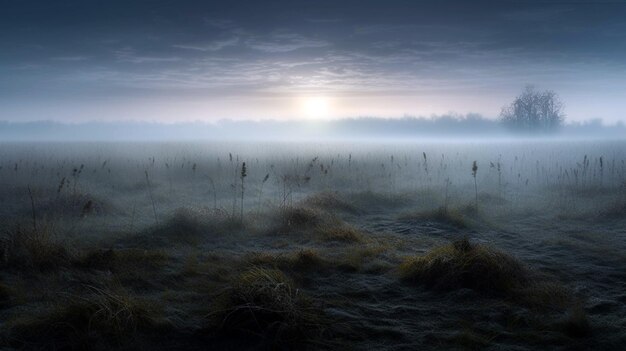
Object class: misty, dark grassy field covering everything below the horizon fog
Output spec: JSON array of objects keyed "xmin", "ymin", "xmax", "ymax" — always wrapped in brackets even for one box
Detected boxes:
[{"xmin": 0, "ymin": 141, "xmax": 626, "ymax": 350}]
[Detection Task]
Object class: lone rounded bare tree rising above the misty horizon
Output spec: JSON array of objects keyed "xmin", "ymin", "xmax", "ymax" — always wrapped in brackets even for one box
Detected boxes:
[{"xmin": 500, "ymin": 86, "xmax": 565, "ymax": 132}]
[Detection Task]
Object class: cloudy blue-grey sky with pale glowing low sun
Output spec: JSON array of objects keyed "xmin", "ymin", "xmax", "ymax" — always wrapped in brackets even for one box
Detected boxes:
[{"xmin": 0, "ymin": 0, "xmax": 626, "ymax": 123}]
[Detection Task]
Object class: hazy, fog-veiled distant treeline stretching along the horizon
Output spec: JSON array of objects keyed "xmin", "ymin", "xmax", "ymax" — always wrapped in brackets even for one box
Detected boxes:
[{"xmin": 0, "ymin": 114, "xmax": 626, "ymax": 141}]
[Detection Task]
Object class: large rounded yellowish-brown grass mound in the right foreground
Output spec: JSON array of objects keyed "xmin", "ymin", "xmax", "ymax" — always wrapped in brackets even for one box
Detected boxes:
[{"xmin": 399, "ymin": 239, "xmax": 569, "ymax": 307}]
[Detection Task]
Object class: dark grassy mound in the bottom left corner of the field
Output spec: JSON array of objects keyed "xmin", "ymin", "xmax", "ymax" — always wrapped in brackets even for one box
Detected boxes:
[{"xmin": 8, "ymin": 288, "xmax": 166, "ymax": 350}]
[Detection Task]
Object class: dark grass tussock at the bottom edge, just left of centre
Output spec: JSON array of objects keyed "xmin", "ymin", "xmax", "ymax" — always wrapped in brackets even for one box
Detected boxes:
[{"xmin": 207, "ymin": 268, "xmax": 323, "ymax": 349}]
